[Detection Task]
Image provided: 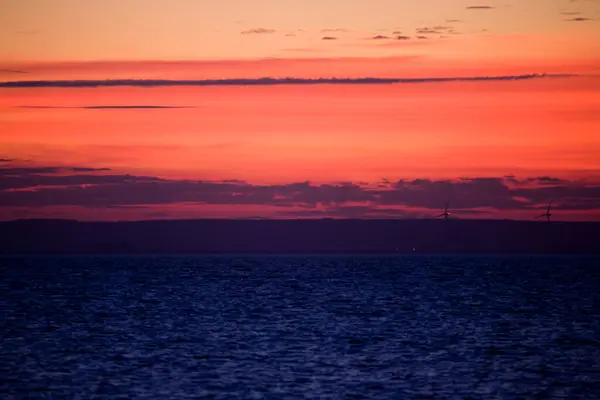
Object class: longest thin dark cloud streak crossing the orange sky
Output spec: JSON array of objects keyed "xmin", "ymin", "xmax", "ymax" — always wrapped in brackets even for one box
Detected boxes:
[{"xmin": 0, "ymin": 73, "xmax": 579, "ymax": 88}]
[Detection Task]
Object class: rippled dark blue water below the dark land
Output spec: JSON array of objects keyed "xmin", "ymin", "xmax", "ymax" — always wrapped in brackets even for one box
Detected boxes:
[{"xmin": 0, "ymin": 256, "xmax": 600, "ymax": 399}]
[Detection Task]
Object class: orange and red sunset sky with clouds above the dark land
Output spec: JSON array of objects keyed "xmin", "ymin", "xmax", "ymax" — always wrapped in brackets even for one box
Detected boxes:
[{"xmin": 0, "ymin": 0, "xmax": 600, "ymax": 220}]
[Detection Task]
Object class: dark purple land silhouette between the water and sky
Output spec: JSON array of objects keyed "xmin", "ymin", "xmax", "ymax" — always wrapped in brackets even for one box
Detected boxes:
[{"xmin": 0, "ymin": 219, "xmax": 600, "ymax": 254}]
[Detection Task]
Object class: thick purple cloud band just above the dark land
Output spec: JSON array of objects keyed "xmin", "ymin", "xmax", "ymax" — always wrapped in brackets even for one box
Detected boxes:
[{"xmin": 0, "ymin": 162, "xmax": 600, "ymax": 213}]
